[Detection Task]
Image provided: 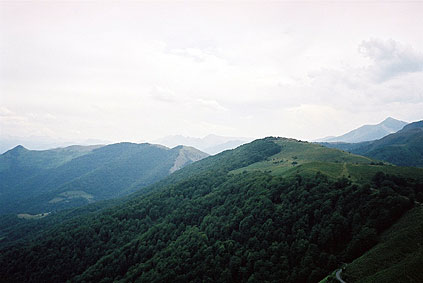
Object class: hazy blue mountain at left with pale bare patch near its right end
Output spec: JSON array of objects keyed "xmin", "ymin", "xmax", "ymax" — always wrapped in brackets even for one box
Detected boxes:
[{"xmin": 0, "ymin": 143, "xmax": 207, "ymax": 214}]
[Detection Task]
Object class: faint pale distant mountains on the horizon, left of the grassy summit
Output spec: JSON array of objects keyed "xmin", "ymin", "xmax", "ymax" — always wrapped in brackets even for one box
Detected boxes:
[{"xmin": 154, "ymin": 135, "xmax": 252, "ymax": 155}]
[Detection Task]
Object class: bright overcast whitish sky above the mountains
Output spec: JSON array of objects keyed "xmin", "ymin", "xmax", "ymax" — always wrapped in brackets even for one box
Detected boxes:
[{"xmin": 0, "ymin": 1, "xmax": 423, "ymax": 146}]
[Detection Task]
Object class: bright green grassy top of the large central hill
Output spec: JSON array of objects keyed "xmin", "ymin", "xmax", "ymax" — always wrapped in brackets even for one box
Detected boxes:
[{"xmin": 232, "ymin": 138, "xmax": 423, "ymax": 183}]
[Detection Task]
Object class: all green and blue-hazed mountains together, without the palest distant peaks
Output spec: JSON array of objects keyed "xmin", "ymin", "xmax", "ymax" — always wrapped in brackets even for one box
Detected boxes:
[{"xmin": 0, "ymin": 121, "xmax": 423, "ymax": 282}]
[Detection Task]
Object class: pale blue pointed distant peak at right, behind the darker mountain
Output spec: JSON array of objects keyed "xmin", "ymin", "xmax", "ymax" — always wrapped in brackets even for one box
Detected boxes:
[{"xmin": 317, "ymin": 117, "xmax": 407, "ymax": 143}]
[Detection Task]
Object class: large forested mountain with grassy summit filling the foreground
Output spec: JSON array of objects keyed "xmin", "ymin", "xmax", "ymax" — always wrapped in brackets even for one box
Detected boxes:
[{"xmin": 0, "ymin": 137, "xmax": 423, "ymax": 282}]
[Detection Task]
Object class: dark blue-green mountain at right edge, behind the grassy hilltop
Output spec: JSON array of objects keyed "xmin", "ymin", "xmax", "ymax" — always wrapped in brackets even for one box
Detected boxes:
[{"xmin": 323, "ymin": 121, "xmax": 423, "ymax": 167}]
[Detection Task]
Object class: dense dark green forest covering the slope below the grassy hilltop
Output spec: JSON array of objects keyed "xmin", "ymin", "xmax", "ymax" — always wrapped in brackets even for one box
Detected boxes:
[{"xmin": 0, "ymin": 169, "xmax": 422, "ymax": 282}]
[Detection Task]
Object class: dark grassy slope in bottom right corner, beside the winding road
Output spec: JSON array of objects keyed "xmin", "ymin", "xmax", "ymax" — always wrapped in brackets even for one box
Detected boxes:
[{"xmin": 343, "ymin": 206, "xmax": 423, "ymax": 282}]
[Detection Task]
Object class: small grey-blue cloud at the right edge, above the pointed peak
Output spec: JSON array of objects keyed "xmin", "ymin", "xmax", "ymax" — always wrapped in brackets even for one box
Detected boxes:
[{"xmin": 359, "ymin": 39, "xmax": 423, "ymax": 82}]
